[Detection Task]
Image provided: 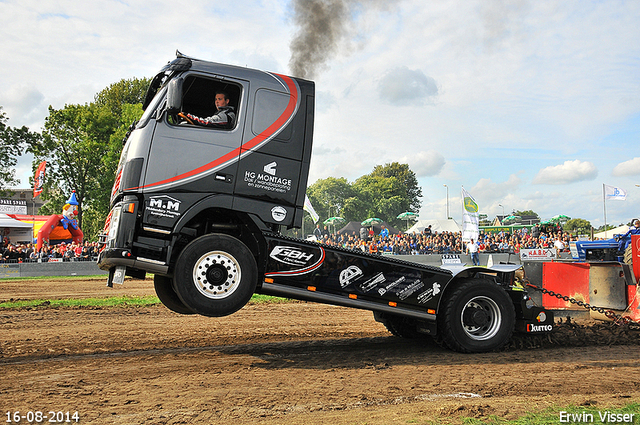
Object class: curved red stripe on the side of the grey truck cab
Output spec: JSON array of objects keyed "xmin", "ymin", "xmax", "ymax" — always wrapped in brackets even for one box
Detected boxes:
[{"xmin": 136, "ymin": 74, "xmax": 298, "ymax": 190}]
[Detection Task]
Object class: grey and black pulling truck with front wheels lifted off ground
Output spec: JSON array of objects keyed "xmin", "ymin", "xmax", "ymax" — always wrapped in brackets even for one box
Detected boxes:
[{"xmin": 98, "ymin": 52, "xmax": 554, "ymax": 352}]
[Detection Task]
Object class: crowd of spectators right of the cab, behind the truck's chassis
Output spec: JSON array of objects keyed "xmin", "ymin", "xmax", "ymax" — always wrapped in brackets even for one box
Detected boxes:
[{"xmin": 310, "ymin": 225, "xmax": 577, "ymax": 255}]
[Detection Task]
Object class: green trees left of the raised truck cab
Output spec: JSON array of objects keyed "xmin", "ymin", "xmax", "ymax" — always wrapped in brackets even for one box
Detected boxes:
[{"xmin": 0, "ymin": 78, "xmax": 150, "ymax": 240}]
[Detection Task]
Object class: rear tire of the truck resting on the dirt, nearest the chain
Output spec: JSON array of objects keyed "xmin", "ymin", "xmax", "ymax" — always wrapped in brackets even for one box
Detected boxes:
[{"xmin": 437, "ymin": 279, "xmax": 515, "ymax": 353}]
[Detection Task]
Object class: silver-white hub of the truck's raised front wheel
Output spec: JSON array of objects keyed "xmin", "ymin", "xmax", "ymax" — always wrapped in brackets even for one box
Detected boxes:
[{"xmin": 193, "ymin": 251, "xmax": 240, "ymax": 299}]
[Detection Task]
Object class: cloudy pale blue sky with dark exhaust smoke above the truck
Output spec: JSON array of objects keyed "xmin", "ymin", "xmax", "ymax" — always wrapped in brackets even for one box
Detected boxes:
[{"xmin": 0, "ymin": 0, "xmax": 640, "ymax": 227}]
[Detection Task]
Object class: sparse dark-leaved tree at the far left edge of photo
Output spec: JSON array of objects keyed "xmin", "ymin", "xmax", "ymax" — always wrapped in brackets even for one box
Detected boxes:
[{"xmin": 0, "ymin": 106, "xmax": 40, "ymax": 196}]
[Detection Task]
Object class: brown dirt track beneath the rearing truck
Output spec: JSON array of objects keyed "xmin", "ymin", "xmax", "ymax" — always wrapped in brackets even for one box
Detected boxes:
[{"xmin": 0, "ymin": 279, "xmax": 640, "ymax": 424}]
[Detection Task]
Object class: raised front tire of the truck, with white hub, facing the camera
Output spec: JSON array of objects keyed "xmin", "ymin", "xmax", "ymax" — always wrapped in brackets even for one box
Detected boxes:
[{"xmin": 173, "ymin": 234, "xmax": 258, "ymax": 317}]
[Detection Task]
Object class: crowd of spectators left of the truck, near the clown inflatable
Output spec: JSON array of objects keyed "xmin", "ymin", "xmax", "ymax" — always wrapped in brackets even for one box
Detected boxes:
[{"xmin": 0, "ymin": 238, "xmax": 98, "ymax": 263}]
